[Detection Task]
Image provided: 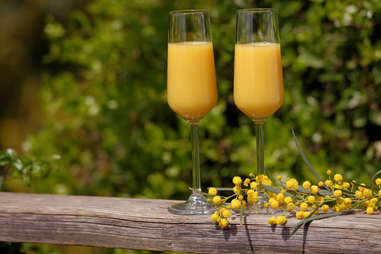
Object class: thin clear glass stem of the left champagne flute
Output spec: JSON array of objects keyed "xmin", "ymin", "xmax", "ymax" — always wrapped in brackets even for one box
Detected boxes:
[{"xmin": 191, "ymin": 123, "xmax": 201, "ymax": 193}]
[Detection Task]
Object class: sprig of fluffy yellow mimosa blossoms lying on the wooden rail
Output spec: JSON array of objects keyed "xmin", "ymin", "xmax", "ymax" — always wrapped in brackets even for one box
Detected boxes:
[{"xmin": 205, "ymin": 131, "xmax": 381, "ymax": 235}]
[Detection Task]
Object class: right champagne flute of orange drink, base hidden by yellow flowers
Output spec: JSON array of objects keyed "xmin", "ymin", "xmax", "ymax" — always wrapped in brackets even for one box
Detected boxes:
[{"xmin": 234, "ymin": 8, "xmax": 283, "ymax": 213}]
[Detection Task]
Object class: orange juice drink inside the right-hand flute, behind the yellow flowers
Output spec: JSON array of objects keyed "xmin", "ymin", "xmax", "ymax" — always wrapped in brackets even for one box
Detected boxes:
[{"xmin": 234, "ymin": 43, "xmax": 283, "ymax": 121}]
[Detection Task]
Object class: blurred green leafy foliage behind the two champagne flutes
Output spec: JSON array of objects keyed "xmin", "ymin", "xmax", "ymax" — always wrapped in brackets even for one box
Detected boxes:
[{"xmin": 3, "ymin": 0, "xmax": 381, "ymax": 252}]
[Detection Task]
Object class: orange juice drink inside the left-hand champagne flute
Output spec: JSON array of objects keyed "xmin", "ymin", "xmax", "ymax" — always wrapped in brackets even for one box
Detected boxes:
[{"xmin": 167, "ymin": 42, "xmax": 217, "ymax": 123}]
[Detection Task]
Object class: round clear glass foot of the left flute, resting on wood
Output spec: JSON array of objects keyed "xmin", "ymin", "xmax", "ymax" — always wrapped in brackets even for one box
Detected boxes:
[{"xmin": 168, "ymin": 192, "xmax": 214, "ymax": 215}]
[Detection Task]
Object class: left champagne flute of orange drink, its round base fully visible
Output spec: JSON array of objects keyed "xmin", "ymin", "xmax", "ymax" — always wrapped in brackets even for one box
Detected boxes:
[{"xmin": 167, "ymin": 10, "xmax": 217, "ymax": 215}]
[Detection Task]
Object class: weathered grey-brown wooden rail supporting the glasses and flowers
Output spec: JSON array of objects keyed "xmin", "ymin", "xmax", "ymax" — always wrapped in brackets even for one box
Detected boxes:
[{"xmin": 0, "ymin": 192, "xmax": 381, "ymax": 253}]
